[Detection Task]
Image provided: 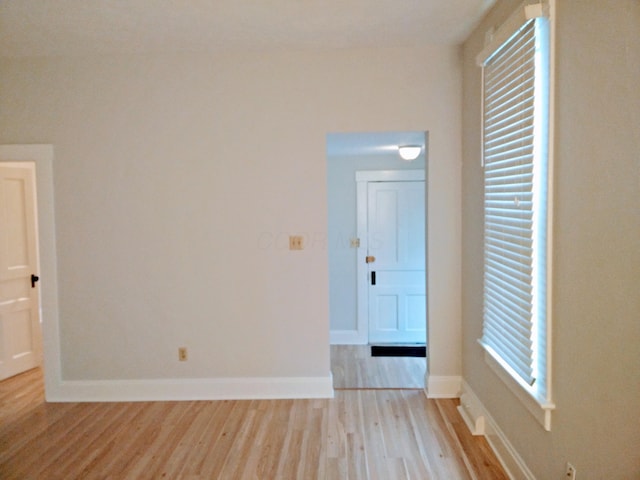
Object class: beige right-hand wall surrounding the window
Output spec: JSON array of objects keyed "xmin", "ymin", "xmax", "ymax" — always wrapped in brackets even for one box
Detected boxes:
[{"xmin": 462, "ymin": 0, "xmax": 640, "ymax": 479}]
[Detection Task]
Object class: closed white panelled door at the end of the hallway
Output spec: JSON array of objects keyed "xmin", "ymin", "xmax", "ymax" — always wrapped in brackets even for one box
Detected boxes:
[{"xmin": 367, "ymin": 181, "xmax": 427, "ymax": 343}]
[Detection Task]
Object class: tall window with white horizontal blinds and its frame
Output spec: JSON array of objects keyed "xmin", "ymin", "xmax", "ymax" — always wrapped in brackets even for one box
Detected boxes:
[{"xmin": 478, "ymin": 5, "xmax": 553, "ymax": 429}]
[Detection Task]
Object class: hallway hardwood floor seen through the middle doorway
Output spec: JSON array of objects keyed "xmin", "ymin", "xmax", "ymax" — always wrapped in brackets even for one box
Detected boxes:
[{"xmin": 331, "ymin": 345, "xmax": 426, "ymax": 389}]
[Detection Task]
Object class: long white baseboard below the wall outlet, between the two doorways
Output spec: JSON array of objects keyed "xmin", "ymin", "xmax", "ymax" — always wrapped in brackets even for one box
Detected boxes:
[{"xmin": 46, "ymin": 374, "xmax": 334, "ymax": 402}]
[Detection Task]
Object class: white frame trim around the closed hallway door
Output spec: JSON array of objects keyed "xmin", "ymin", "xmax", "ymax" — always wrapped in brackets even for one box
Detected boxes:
[{"xmin": 355, "ymin": 169, "xmax": 428, "ymax": 345}]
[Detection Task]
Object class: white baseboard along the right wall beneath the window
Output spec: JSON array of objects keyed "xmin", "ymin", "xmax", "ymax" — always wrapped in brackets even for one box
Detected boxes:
[{"xmin": 458, "ymin": 380, "xmax": 535, "ymax": 480}]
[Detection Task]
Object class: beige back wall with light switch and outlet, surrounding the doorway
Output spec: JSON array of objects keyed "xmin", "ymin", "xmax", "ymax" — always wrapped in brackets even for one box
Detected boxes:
[{"xmin": 0, "ymin": 47, "xmax": 461, "ymax": 386}]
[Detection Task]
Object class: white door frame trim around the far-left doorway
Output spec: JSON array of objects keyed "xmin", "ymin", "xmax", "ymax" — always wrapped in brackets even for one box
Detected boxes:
[{"xmin": 0, "ymin": 145, "xmax": 62, "ymax": 399}]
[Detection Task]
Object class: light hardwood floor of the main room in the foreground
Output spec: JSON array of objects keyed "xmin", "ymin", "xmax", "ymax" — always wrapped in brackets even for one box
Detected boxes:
[{"xmin": 0, "ymin": 369, "xmax": 507, "ymax": 480}]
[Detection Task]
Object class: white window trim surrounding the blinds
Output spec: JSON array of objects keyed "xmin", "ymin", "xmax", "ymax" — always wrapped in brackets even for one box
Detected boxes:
[{"xmin": 476, "ymin": 0, "xmax": 555, "ymax": 431}]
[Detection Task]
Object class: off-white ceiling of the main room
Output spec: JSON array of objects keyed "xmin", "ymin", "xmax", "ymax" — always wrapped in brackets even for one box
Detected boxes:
[{"xmin": 0, "ymin": 0, "xmax": 495, "ymax": 57}]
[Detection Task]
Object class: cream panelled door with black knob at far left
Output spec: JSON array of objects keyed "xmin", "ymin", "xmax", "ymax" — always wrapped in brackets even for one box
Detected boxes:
[{"xmin": 0, "ymin": 163, "xmax": 42, "ymax": 380}]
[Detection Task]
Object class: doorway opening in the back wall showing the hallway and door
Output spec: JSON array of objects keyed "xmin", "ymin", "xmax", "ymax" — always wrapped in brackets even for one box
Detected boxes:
[{"xmin": 327, "ymin": 132, "xmax": 427, "ymax": 388}]
